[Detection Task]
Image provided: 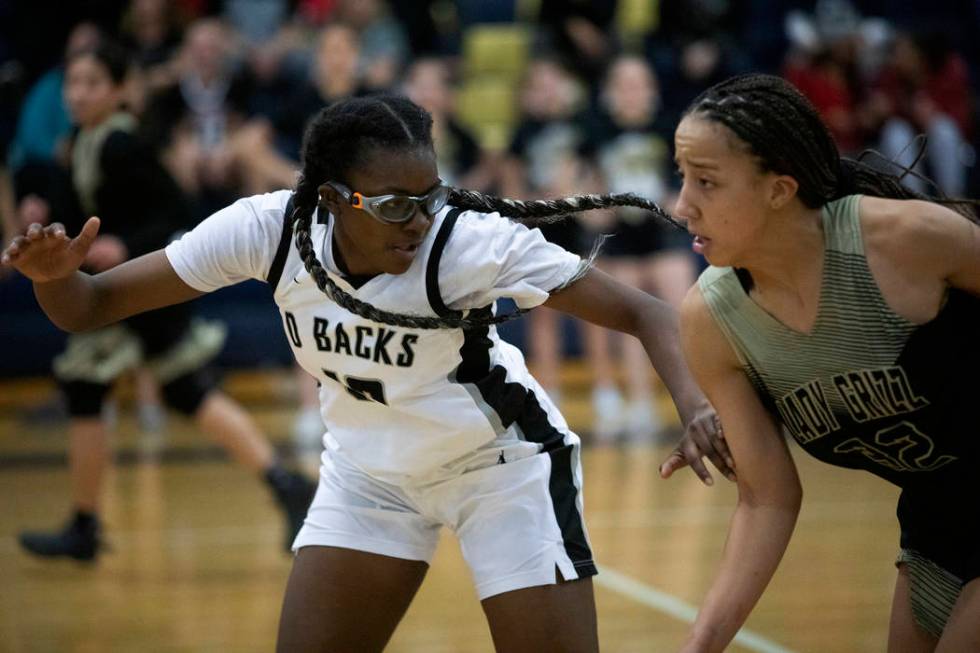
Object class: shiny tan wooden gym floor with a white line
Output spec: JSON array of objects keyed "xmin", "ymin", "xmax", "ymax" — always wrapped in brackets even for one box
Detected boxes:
[{"xmin": 0, "ymin": 364, "xmax": 898, "ymax": 653}]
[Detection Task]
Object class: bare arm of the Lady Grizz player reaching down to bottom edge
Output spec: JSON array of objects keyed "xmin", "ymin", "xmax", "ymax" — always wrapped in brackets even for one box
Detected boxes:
[{"xmin": 681, "ymin": 286, "xmax": 803, "ymax": 653}]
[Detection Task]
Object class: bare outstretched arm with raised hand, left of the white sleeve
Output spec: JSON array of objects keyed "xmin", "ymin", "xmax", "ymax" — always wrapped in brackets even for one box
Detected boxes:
[{"xmin": 0, "ymin": 218, "xmax": 202, "ymax": 331}]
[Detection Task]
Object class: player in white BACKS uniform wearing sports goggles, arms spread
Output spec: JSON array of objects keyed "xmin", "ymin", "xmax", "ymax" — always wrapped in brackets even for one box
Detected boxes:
[{"xmin": 3, "ymin": 96, "xmax": 732, "ymax": 652}]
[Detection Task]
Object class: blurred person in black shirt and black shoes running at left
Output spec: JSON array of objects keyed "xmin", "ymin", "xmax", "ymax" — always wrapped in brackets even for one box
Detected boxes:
[{"xmin": 20, "ymin": 43, "xmax": 314, "ymax": 560}]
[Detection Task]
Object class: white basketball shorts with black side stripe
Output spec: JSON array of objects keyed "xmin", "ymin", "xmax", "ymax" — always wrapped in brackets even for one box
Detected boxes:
[{"xmin": 293, "ymin": 441, "xmax": 596, "ymax": 601}]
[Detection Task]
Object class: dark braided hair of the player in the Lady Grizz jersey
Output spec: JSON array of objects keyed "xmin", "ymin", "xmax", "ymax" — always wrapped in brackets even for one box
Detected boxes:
[{"xmin": 684, "ymin": 74, "xmax": 980, "ymax": 222}]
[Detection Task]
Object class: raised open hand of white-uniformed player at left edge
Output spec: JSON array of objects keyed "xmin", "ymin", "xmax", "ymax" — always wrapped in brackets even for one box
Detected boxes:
[{"xmin": 0, "ymin": 217, "xmax": 99, "ymax": 283}]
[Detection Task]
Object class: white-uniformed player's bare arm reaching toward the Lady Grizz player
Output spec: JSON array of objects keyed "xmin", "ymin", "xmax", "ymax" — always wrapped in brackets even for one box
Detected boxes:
[{"xmin": 544, "ymin": 268, "xmax": 734, "ymax": 485}]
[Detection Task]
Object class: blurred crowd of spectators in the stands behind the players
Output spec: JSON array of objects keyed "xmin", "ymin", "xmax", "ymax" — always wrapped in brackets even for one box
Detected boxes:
[{"xmin": 0, "ymin": 0, "xmax": 980, "ymax": 444}]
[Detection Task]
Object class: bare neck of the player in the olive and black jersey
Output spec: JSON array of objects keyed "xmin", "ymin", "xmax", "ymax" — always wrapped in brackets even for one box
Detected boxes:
[{"xmin": 733, "ymin": 208, "xmax": 824, "ymax": 291}]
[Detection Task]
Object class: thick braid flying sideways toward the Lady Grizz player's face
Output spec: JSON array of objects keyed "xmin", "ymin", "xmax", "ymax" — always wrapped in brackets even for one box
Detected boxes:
[{"xmin": 449, "ymin": 188, "xmax": 687, "ymax": 231}]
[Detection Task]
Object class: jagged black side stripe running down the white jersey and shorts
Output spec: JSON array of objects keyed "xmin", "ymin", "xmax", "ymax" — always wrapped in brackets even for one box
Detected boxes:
[{"xmin": 452, "ymin": 314, "xmax": 598, "ymax": 580}]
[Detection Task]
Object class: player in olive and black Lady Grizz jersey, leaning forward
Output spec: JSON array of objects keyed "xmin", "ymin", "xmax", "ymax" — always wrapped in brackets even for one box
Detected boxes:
[{"xmin": 663, "ymin": 75, "xmax": 980, "ymax": 651}]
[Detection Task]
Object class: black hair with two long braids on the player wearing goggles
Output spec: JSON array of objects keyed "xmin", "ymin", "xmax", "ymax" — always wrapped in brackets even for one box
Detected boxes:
[{"xmin": 290, "ymin": 95, "xmax": 684, "ymax": 329}]
